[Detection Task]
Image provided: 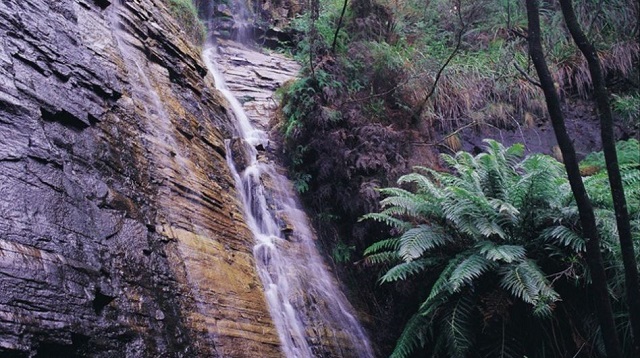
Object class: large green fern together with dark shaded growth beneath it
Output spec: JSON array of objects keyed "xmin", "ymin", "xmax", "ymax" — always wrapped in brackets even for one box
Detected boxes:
[{"xmin": 365, "ymin": 140, "xmax": 640, "ymax": 357}]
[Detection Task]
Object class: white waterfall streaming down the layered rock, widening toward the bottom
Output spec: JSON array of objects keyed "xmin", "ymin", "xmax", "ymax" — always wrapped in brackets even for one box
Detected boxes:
[{"xmin": 203, "ymin": 31, "xmax": 373, "ymax": 358}]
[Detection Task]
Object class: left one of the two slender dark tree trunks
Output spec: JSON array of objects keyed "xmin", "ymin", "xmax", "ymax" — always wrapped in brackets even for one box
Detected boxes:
[{"xmin": 526, "ymin": 0, "xmax": 622, "ymax": 358}]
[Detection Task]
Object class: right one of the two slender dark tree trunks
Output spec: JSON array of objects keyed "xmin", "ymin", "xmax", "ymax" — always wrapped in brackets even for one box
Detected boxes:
[{"xmin": 560, "ymin": 0, "xmax": 640, "ymax": 357}]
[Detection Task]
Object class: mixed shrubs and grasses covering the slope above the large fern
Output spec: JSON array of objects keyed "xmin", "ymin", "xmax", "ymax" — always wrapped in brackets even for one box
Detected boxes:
[{"xmin": 280, "ymin": 0, "xmax": 640, "ymax": 253}]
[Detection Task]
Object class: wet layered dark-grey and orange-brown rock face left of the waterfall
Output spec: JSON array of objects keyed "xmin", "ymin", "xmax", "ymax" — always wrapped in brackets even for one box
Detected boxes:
[{"xmin": 0, "ymin": 0, "xmax": 281, "ymax": 357}]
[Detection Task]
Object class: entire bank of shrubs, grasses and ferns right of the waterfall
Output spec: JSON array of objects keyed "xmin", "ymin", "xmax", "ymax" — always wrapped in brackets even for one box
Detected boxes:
[{"xmin": 279, "ymin": 0, "xmax": 640, "ymax": 358}]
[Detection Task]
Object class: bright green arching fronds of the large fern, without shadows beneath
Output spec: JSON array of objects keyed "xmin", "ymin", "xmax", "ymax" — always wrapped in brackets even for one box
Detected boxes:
[{"xmin": 363, "ymin": 140, "xmax": 640, "ymax": 357}]
